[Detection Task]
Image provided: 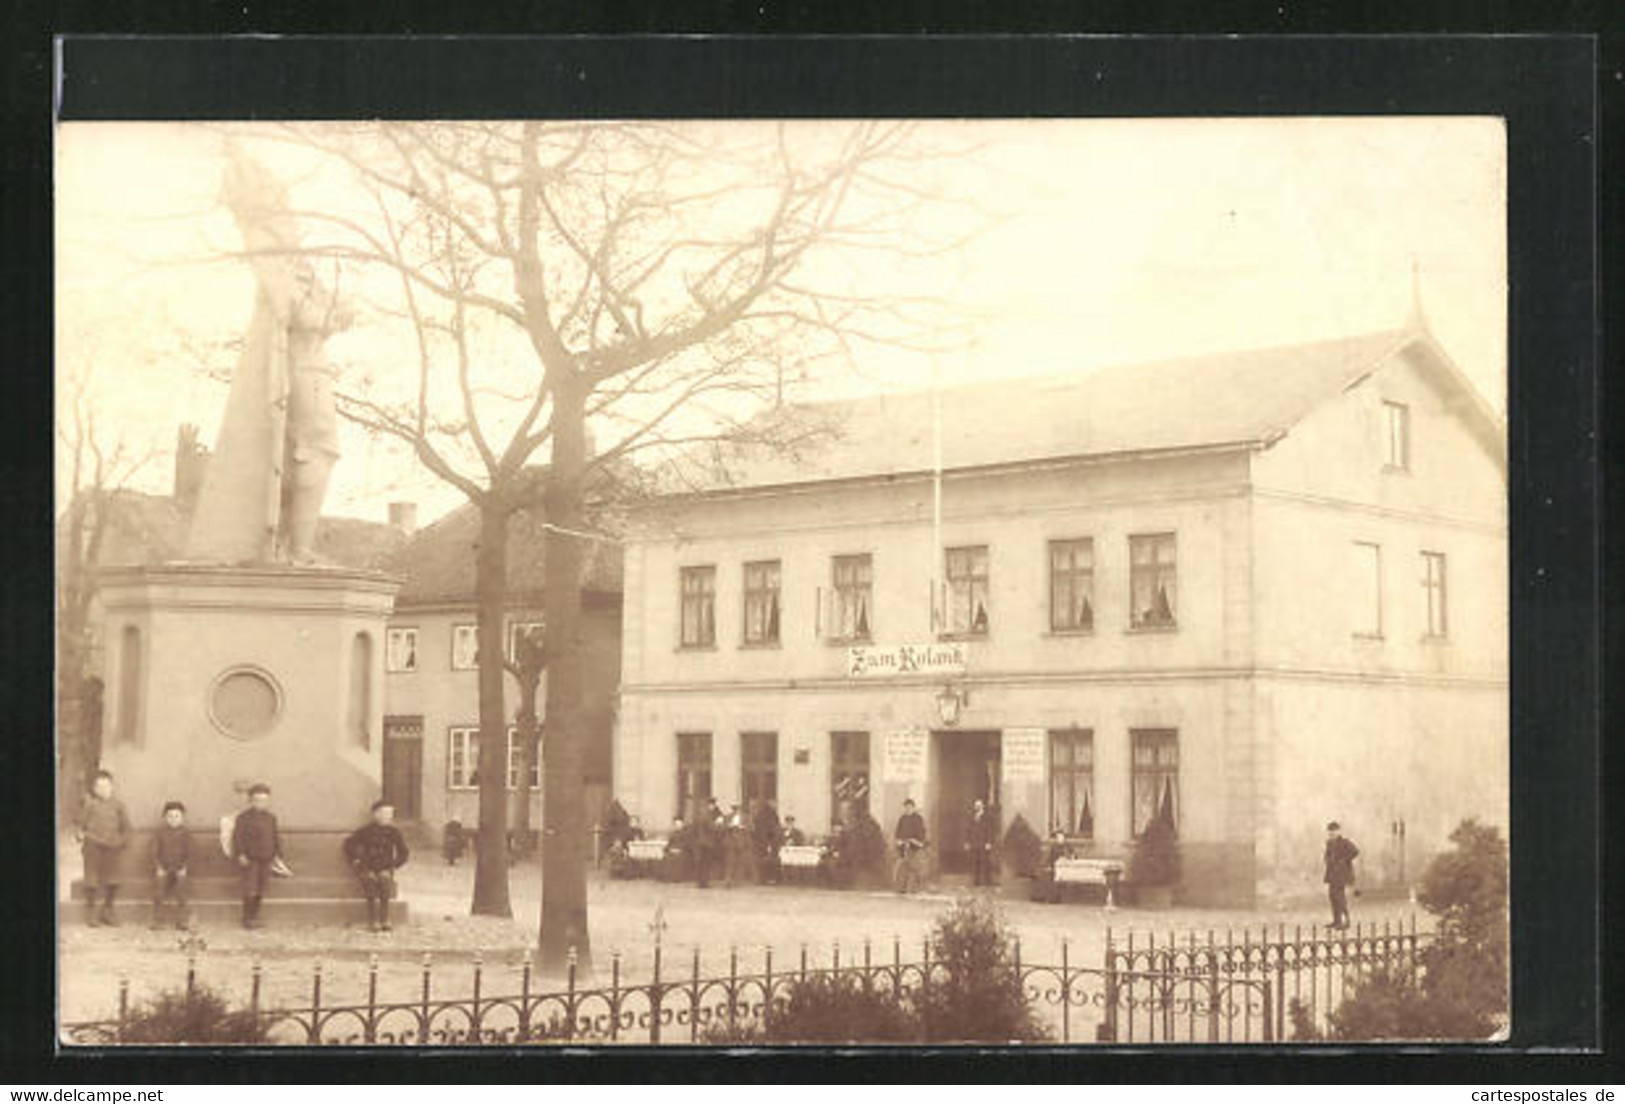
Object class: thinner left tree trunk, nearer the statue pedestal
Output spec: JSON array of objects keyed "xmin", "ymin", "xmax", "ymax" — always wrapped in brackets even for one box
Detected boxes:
[{"xmin": 470, "ymin": 504, "xmax": 514, "ymax": 917}]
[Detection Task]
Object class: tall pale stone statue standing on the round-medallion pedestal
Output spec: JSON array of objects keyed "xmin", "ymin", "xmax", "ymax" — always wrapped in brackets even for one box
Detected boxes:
[{"xmin": 187, "ymin": 148, "xmax": 353, "ymax": 564}]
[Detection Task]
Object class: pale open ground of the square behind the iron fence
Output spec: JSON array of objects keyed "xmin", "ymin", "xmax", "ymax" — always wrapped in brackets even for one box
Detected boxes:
[{"xmin": 60, "ymin": 863, "xmax": 1425, "ymax": 1023}]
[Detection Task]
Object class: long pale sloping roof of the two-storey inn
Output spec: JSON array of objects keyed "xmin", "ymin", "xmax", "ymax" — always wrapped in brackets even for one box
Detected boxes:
[{"xmin": 676, "ymin": 328, "xmax": 1493, "ymax": 491}]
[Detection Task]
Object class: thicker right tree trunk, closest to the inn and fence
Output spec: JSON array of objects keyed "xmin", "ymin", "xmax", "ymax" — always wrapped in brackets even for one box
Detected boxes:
[{"xmin": 538, "ymin": 389, "xmax": 592, "ymax": 971}]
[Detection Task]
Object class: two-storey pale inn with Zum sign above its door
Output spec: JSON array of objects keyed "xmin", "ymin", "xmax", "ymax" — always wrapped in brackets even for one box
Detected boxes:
[{"xmin": 614, "ymin": 325, "xmax": 1508, "ymax": 904}]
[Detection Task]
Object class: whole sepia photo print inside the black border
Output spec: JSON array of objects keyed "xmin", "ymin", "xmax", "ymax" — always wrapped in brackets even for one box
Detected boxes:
[{"xmin": 54, "ymin": 115, "xmax": 1511, "ymax": 1050}]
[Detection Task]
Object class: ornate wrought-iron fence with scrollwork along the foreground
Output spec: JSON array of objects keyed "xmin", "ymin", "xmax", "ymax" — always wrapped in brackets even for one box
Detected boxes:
[{"xmin": 63, "ymin": 920, "xmax": 1427, "ymax": 1045}]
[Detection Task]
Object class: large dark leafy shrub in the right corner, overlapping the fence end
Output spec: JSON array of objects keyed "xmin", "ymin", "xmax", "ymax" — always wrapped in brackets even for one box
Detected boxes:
[{"xmin": 1331, "ymin": 819, "xmax": 1508, "ymax": 1041}]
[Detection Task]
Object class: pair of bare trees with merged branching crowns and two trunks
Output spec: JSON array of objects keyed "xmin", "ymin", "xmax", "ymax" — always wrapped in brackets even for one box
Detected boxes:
[{"xmin": 216, "ymin": 122, "xmax": 975, "ymax": 967}]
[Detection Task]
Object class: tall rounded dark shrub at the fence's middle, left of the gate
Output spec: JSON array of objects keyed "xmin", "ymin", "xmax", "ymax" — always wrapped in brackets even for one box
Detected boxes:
[{"xmin": 915, "ymin": 898, "xmax": 1050, "ymax": 1042}]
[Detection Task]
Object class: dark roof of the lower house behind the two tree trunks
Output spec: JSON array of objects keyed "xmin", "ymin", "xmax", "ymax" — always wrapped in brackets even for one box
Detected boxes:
[{"xmin": 385, "ymin": 484, "xmax": 621, "ymax": 606}]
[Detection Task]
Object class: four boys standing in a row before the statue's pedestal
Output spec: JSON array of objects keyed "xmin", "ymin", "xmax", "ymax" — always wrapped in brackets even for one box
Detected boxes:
[{"xmin": 75, "ymin": 771, "xmax": 410, "ymax": 932}]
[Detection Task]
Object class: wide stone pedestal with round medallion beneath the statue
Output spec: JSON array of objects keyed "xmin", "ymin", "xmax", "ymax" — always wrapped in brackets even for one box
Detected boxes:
[{"xmin": 75, "ymin": 564, "xmax": 405, "ymax": 924}]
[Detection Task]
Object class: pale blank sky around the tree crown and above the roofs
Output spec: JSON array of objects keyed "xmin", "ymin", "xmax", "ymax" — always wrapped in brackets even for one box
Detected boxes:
[{"xmin": 57, "ymin": 119, "xmax": 1506, "ymax": 520}]
